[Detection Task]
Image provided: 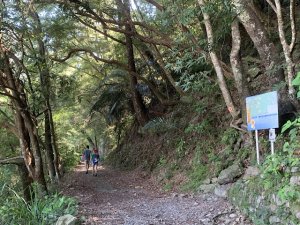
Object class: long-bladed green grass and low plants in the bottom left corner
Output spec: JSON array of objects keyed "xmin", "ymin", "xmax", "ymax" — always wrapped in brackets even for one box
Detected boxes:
[{"xmin": 0, "ymin": 185, "xmax": 77, "ymax": 225}]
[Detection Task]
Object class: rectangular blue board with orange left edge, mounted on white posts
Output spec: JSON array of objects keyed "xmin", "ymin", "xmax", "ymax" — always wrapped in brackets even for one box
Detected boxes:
[{"xmin": 246, "ymin": 91, "xmax": 279, "ymax": 130}]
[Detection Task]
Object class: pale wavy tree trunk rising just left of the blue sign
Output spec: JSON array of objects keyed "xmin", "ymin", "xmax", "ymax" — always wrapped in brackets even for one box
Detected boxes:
[{"xmin": 230, "ymin": 20, "xmax": 249, "ymax": 124}]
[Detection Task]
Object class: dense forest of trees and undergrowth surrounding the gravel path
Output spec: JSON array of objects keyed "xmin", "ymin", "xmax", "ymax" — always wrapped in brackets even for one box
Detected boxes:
[{"xmin": 0, "ymin": 0, "xmax": 300, "ymax": 224}]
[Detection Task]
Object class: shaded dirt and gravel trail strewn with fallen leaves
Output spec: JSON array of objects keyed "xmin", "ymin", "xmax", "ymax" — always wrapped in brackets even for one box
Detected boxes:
[{"xmin": 62, "ymin": 164, "xmax": 251, "ymax": 225}]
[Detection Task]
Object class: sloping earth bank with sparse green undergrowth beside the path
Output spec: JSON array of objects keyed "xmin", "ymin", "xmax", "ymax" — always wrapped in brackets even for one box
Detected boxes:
[{"xmin": 107, "ymin": 75, "xmax": 249, "ymax": 191}]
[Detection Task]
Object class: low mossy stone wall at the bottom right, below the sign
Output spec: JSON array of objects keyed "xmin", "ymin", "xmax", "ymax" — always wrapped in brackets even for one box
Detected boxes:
[{"xmin": 228, "ymin": 176, "xmax": 300, "ymax": 225}]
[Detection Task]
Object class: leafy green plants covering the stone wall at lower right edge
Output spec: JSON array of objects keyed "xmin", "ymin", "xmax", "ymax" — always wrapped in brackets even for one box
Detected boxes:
[{"xmin": 229, "ymin": 119, "xmax": 300, "ymax": 224}]
